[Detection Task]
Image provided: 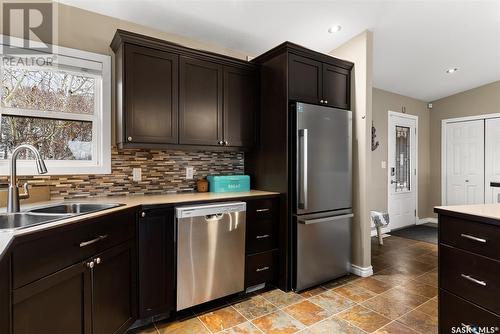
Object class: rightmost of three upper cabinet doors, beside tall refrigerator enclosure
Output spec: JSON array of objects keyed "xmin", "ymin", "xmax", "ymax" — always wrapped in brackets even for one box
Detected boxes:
[{"xmin": 224, "ymin": 66, "xmax": 259, "ymax": 147}]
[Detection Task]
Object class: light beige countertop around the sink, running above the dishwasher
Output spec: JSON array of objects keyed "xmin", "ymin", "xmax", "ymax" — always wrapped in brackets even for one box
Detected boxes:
[{"xmin": 0, "ymin": 190, "xmax": 278, "ymax": 259}]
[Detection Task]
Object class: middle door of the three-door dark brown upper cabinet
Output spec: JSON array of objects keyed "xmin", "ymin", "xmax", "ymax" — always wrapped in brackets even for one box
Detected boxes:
[{"xmin": 179, "ymin": 57, "xmax": 223, "ymax": 145}]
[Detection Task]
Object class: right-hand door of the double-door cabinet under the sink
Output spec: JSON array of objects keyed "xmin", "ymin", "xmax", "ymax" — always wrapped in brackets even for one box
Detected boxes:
[{"xmin": 93, "ymin": 242, "xmax": 136, "ymax": 334}]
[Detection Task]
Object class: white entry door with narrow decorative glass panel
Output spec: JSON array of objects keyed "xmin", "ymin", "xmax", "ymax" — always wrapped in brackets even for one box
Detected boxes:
[{"xmin": 387, "ymin": 112, "xmax": 417, "ymax": 229}]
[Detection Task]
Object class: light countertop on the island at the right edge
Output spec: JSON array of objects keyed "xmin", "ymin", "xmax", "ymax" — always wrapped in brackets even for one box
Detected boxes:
[{"xmin": 434, "ymin": 203, "xmax": 500, "ymax": 226}]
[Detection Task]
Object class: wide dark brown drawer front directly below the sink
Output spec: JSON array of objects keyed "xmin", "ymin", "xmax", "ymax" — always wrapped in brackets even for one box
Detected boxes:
[{"xmin": 12, "ymin": 210, "xmax": 135, "ymax": 288}]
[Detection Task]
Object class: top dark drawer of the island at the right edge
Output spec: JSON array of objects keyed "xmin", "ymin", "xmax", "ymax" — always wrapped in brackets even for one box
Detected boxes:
[{"xmin": 439, "ymin": 215, "xmax": 500, "ymax": 260}]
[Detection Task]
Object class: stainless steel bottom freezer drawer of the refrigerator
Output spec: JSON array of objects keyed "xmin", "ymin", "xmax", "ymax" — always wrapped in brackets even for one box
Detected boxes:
[{"xmin": 295, "ymin": 213, "xmax": 353, "ymax": 291}]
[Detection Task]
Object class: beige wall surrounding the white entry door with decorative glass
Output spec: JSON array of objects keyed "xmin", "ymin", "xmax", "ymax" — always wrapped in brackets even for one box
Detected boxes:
[{"xmin": 370, "ymin": 88, "xmax": 432, "ymax": 218}]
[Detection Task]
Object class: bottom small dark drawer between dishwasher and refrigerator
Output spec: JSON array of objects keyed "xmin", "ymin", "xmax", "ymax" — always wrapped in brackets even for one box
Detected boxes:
[{"xmin": 245, "ymin": 251, "xmax": 277, "ymax": 288}]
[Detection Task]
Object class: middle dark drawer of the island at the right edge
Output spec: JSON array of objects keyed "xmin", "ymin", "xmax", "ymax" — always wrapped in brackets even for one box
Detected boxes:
[{"xmin": 439, "ymin": 245, "xmax": 500, "ymax": 313}]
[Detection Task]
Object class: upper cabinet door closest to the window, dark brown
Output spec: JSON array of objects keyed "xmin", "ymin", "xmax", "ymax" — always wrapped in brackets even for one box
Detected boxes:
[{"xmin": 123, "ymin": 44, "xmax": 179, "ymax": 144}]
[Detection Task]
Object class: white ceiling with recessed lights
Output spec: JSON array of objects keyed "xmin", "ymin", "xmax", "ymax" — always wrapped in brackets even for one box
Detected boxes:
[{"xmin": 59, "ymin": 0, "xmax": 500, "ymax": 101}]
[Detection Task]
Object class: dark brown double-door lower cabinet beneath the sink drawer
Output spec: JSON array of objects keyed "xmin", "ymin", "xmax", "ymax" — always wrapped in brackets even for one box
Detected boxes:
[{"xmin": 12, "ymin": 242, "xmax": 135, "ymax": 334}]
